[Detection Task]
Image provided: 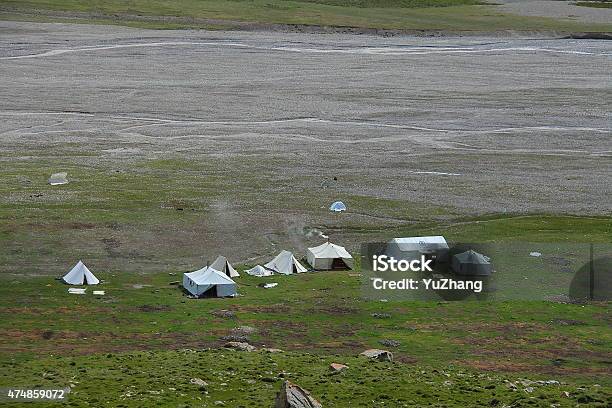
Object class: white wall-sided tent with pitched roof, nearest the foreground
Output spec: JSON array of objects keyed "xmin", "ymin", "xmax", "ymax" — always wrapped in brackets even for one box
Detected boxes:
[{"xmin": 183, "ymin": 266, "xmax": 237, "ymax": 297}]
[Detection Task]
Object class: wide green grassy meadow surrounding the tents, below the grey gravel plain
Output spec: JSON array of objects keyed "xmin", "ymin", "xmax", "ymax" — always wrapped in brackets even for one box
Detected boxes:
[{"xmin": 0, "ymin": 157, "xmax": 612, "ymax": 407}]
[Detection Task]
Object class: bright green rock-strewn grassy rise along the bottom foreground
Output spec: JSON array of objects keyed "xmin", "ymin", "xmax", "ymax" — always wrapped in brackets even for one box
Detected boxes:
[{"xmin": 0, "ymin": 350, "xmax": 609, "ymax": 408}]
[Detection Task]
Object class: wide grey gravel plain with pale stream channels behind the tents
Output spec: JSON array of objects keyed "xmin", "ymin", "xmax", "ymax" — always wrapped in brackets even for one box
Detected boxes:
[{"xmin": 0, "ymin": 22, "xmax": 612, "ymax": 264}]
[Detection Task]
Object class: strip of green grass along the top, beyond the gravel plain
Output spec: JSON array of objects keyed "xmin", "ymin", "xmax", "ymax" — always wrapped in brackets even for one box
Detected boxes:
[{"xmin": 0, "ymin": 0, "xmax": 612, "ymax": 32}]
